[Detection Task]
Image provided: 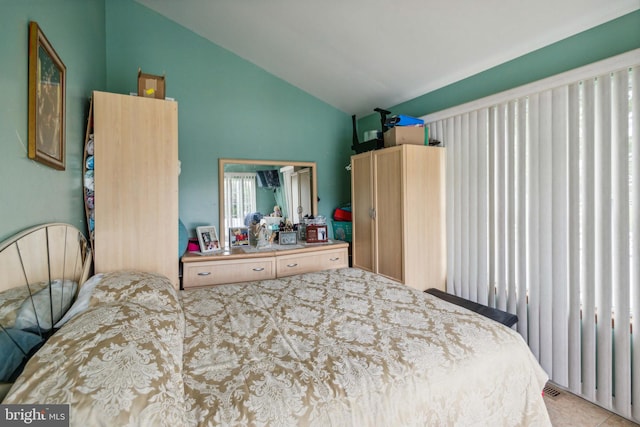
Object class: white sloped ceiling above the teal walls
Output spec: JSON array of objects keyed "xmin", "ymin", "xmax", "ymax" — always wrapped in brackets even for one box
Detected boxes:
[{"xmin": 136, "ymin": 0, "xmax": 640, "ymax": 115}]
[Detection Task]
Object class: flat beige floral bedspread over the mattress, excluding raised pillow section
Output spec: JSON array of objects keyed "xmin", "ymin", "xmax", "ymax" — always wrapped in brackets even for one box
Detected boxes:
[{"xmin": 182, "ymin": 269, "xmax": 550, "ymax": 426}]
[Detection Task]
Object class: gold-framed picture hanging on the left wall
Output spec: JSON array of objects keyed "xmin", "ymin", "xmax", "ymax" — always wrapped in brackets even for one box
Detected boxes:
[{"xmin": 28, "ymin": 21, "xmax": 67, "ymax": 170}]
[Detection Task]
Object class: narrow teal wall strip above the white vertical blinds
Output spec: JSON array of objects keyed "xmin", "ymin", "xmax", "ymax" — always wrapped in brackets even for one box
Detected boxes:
[{"xmin": 358, "ymin": 10, "xmax": 640, "ymax": 134}]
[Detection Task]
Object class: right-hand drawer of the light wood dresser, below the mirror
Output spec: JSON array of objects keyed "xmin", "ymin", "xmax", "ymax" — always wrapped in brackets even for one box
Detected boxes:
[{"xmin": 276, "ymin": 248, "xmax": 349, "ymax": 277}]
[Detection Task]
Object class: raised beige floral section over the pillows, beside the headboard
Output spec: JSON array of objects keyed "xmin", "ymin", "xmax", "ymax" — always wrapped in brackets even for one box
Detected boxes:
[{"xmin": 2, "ymin": 272, "xmax": 186, "ymax": 427}]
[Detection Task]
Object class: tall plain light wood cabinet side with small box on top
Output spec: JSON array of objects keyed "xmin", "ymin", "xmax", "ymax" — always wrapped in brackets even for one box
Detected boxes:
[{"xmin": 90, "ymin": 92, "xmax": 179, "ymax": 289}]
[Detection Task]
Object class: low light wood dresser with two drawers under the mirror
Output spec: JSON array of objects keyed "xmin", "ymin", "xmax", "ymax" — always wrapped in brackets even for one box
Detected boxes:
[{"xmin": 182, "ymin": 241, "xmax": 349, "ymax": 289}]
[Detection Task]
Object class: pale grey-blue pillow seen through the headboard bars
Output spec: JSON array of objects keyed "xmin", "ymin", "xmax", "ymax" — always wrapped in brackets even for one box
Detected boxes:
[{"xmin": 14, "ymin": 279, "xmax": 78, "ymax": 331}]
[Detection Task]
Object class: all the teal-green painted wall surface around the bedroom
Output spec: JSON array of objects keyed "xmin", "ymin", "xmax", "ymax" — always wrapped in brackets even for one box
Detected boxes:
[{"xmin": 0, "ymin": 0, "xmax": 640, "ymax": 244}]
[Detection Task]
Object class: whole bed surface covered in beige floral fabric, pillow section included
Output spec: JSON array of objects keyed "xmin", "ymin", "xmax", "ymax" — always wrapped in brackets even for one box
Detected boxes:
[{"xmin": 3, "ymin": 226, "xmax": 550, "ymax": 426}]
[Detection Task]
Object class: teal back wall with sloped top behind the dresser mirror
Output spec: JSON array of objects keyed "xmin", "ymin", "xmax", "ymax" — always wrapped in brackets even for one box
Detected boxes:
[{"xmin": 106, "ymin": 0, "xmax": 351, "ymax": 234}]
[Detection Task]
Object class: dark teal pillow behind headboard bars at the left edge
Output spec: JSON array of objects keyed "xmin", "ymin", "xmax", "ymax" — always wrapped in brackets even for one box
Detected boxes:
[{"xmin": 0, "ymin": 328, "xmax": 42, "ymax": 382}]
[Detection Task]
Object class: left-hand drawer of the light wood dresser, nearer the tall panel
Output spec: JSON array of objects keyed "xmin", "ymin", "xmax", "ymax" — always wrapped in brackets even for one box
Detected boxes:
[{"xmin": 182, "ymin": 257, "xmax": 276, "ymax": 288}]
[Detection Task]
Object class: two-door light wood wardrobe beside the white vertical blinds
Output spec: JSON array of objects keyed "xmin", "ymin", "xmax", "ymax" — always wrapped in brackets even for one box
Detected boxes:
[{"xmin": 351, "ymin": 144, "xmax": 446, "ymax": 290}]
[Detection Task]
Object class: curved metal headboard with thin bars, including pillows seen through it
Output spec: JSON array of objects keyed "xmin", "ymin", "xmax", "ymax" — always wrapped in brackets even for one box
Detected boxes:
[{"xmin": 0, "ymin": 223, "xmax": 92, "ymax": 392}]
